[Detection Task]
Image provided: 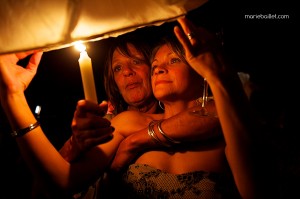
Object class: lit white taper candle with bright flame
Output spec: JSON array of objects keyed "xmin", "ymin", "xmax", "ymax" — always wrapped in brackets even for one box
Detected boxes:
[{"xmin": 78, "ymin": 44, "xmax": 98, "ymax": 103}]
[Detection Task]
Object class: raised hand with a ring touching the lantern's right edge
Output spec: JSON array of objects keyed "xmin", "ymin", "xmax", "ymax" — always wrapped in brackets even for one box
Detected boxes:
[{"xmin": 174, "ymin": 18, "xmax": 225, "ymax": 82}]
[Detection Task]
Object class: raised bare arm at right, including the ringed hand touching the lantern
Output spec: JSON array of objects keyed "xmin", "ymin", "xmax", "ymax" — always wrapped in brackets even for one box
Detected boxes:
[{"xmin": 174, "ymin": 18, "xmax": 265, "ymax": 198}]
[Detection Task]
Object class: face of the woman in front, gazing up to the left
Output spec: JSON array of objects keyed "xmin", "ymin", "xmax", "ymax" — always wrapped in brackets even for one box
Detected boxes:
[{"xmin": 152, "ymin": 44, "xmax": 200, "ymax": 101}]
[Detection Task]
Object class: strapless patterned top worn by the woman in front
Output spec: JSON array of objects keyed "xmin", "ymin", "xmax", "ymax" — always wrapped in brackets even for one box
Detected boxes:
[{"xmin": 97, "ymin": 164, "xmax": 241, "ymax": 199}]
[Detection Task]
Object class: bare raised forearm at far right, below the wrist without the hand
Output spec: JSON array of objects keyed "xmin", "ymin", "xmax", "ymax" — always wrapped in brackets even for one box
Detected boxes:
[{"xmin": 210, "ymin": 71, "xmax": 259, "ymax": 198}]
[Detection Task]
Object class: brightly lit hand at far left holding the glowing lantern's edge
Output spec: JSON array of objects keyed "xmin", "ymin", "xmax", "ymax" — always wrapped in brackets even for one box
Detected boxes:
[{"xmin": 0, "ymin": 51, "xmax": 43, "ymax": 96}]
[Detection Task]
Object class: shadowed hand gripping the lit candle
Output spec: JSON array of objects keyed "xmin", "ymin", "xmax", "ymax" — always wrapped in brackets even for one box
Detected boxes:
[{"xmin": 60, "ymin": 100, "xmax": 114, "ymax": 161}]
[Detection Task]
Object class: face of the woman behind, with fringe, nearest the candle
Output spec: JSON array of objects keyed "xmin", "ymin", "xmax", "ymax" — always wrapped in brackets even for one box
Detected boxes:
[{"xmin": 112, "ymin": 44, "xmax": 152, "ymax": 106}]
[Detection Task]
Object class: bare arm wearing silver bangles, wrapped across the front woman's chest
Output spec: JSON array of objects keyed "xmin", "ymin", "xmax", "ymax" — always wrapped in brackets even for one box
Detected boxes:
[{"xmin": 111, "ymin": 101, "xmax": 222, "ymax": 171}]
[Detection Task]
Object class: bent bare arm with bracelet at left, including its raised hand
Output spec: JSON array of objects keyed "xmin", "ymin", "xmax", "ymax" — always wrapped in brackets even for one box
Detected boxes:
[{"xmin": 0, "ymin": 52, "xmax": 123, "ymax": 196}]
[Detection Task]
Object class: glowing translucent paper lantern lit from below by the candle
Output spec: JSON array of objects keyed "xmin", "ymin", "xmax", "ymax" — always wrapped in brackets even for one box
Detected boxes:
[{"xmin": 0, "ymin": 0, "xmax": 207, "ymax": 54}]
